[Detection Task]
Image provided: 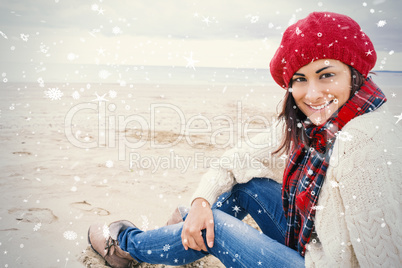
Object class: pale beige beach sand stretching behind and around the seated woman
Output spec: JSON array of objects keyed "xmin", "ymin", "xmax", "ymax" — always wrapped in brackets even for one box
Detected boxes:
[{"xmin": 0, "ymin": 75, "xmax": 401, "ymax": 267}]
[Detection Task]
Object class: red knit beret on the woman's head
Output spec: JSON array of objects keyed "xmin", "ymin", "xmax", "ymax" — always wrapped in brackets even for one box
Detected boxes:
[{"xmin": 270, "ymin": 12, "xmax": 377, "ymax": 88}]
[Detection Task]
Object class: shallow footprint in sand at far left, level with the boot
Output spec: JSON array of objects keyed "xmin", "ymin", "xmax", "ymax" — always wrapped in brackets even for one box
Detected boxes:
[{"xmin": 8, "ymin": 208, "xmax": 58, "ymax": 223}]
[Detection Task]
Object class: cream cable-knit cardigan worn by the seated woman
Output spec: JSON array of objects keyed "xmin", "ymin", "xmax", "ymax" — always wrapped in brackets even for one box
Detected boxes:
[{"xmin": 192, "ymin": 104, "xmax": 402, "ymax": 267}]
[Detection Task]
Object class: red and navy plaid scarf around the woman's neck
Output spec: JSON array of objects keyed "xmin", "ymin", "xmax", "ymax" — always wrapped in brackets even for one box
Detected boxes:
[{"xmin": 282, "ymin": 78, "xmax": 386, "ymax": 256}]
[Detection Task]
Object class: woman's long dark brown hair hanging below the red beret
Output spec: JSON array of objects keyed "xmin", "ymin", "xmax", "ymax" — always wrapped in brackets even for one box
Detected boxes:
[{"xmin": 274, "ymin": 66, "xmax": 364, "ymax": 154}]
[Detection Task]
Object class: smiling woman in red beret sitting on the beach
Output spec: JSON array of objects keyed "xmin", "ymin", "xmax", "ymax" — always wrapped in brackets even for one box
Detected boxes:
[{"xmin": 88, "ymin": 12, "xmax": 402, "ymax": 267}]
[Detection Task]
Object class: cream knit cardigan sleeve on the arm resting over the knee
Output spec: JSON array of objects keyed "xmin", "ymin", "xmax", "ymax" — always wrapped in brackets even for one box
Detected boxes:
[{"xmin": 191, "ymin": 124, "xmax": 285, "ymax": 205}]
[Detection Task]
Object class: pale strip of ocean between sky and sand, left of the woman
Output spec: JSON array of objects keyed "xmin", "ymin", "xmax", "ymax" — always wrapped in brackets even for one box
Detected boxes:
[{"xmin": 2, "ymin": 64, "xmax": 274, "ymax": 86}]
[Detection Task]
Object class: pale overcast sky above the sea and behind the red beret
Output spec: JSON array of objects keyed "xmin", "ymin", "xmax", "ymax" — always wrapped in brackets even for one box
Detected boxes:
[{"xmin": 0, "ymin": 0, "xmax": 402, "ymax": 81}]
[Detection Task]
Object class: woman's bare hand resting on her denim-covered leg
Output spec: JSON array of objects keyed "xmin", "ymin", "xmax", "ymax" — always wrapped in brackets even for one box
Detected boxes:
[{"xmin": 181, "ymin": 198, "xmax": 215, "ymax": 251}]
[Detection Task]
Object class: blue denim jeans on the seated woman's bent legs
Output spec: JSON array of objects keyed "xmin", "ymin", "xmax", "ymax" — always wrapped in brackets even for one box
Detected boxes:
[{"xmin": 118, "ymin": 178, "xmax": 304, "ymax": 267}]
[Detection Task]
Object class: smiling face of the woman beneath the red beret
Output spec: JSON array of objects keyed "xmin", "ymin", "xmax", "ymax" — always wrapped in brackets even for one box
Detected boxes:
[{"xmin": 292, "ymin": 59, "xmax": 351, "ymax": 125}]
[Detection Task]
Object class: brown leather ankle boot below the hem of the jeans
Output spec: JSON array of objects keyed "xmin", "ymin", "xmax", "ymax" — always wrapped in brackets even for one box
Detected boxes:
[{"xmin": 88, "ymin": 220, "xmax": 138, "ymax": 268}]
